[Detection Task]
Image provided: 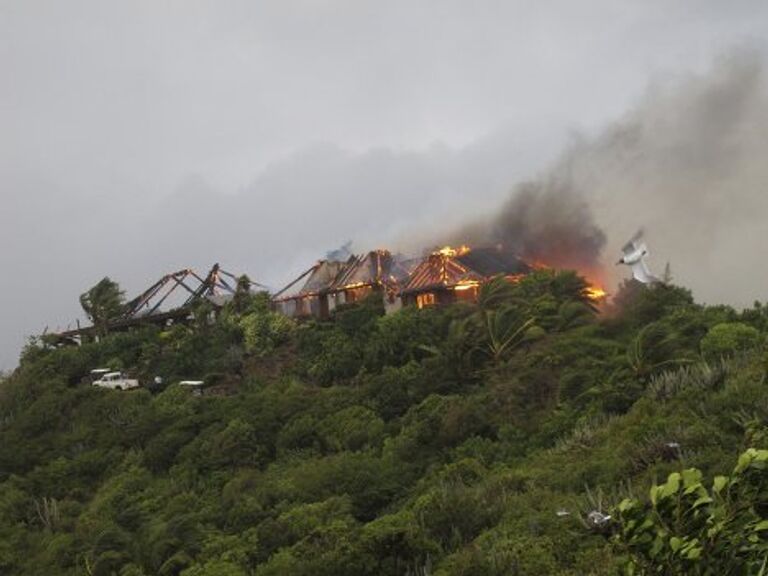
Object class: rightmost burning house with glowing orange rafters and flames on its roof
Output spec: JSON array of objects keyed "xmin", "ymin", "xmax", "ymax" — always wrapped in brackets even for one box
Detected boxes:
[{"xmin": 400, "ymin": 247, "xmax": 531, "ymax": 308}]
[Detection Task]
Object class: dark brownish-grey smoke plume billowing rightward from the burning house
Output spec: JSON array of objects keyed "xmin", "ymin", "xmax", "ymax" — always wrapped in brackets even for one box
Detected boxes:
[{"xmin": 453, "ymin": 51, "xmax": 768, "ymax": 305}]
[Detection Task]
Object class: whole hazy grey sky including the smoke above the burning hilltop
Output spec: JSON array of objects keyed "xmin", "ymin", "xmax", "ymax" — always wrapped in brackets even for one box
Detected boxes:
[{"xmin": 0, "ymin": 0, "xmax": 768, "ymax": 369}]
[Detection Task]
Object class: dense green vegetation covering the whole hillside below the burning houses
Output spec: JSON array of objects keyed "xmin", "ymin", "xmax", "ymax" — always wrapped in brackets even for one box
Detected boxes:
[{"xmin": 0, "ymin": 271, "xmax": 768, "ymax": 576}]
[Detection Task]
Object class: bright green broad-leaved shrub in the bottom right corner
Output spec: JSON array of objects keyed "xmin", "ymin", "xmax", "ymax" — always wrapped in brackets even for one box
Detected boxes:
[{"xmin": 614, "ymin": 449, "xmax": 768, "ymax": 575}]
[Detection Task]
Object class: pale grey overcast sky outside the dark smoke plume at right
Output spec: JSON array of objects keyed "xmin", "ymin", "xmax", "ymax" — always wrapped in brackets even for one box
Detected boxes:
[{"xmin": 0, "ymin": 0, "xmax": 768, "ymax": 368}]
